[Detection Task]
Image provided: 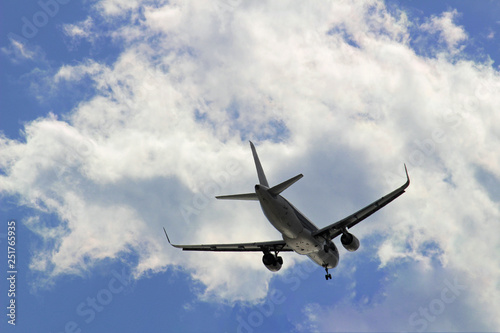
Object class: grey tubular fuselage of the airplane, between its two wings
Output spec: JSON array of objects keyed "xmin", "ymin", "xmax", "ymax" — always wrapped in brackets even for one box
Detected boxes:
[{"xmin": 255, "ymin": 185, "xmax": 339, "ymax": 268}]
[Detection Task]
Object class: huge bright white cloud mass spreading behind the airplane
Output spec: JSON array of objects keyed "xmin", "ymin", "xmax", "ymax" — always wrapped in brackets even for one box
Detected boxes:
[{"xmin": 0, "ymin": 1, "xmax": 500, "ymax": 327}]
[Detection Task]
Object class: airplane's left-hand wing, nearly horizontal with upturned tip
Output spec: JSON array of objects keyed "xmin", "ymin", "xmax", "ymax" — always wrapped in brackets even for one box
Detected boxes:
[{"xmin": 163, "ymin": 228, "xmax": 293, "ymax": 252}]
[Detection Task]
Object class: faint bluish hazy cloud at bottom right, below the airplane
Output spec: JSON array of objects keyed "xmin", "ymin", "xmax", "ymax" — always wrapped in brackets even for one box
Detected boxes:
[{"xmin": 295, "ymin": 265, "xmax": 497, "ymax": 332}]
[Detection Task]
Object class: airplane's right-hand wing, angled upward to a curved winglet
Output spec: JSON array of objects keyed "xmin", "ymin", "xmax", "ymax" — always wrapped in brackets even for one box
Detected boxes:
[{"xmin": 312, "ymin": 165, "xmax": 410, "ymax": 240}]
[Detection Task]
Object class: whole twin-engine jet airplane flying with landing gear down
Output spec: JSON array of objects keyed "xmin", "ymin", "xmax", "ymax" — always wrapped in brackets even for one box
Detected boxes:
[{"xmin": 163, "ymin": 141, "xmax": 410, "ymax": 280}]
